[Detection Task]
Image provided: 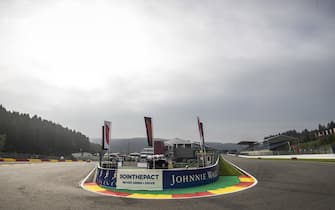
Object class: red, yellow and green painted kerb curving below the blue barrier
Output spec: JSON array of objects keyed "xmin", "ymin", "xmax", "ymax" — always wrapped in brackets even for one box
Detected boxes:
[{"xmin": 82, "ymin": 176, "xmax": 257, "ymax": 199}]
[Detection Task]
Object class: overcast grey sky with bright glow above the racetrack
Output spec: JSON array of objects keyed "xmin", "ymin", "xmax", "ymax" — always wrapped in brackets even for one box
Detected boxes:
[{"xmin": 0, "ymin": 0, "xmax": 335, "ymax": 142}]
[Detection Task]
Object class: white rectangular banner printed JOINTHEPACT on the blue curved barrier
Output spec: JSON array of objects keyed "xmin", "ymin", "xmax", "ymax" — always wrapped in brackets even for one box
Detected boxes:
[{"xmin": 116, "ymin": 169, "xmax": 163, "ymax": 190}]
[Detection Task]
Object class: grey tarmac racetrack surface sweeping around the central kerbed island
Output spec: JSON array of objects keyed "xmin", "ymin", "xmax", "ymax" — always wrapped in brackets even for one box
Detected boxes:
[{"xmin": 0, "ymin": 156, "xmax": 335, "ymax": 210}]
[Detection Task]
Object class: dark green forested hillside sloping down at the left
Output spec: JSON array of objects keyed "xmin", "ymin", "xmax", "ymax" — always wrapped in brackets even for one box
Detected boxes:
[{"xmin": 0, "ymin": 105, "xmax": 100, "ymax": 155}]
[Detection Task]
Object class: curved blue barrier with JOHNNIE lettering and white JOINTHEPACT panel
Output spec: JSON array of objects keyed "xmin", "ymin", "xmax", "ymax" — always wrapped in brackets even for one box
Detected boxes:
[{"xmin": 95, "ymin": 159, "xmax": 219, "ymax": 190}]
